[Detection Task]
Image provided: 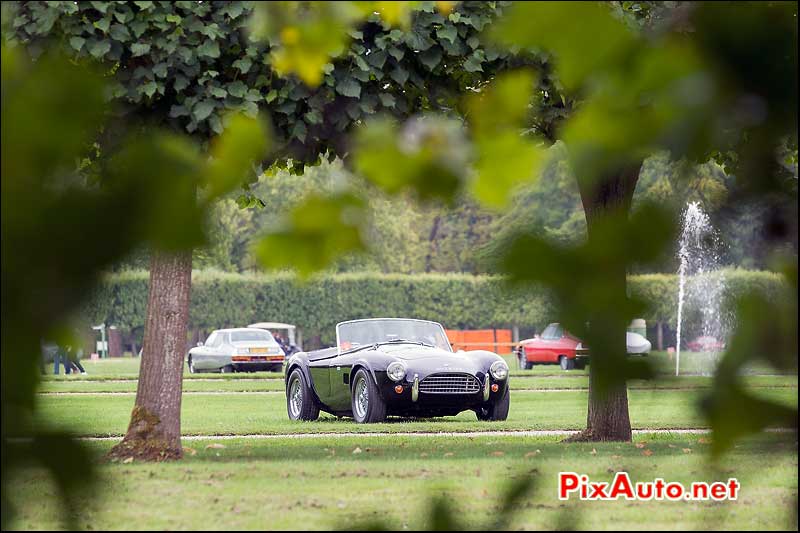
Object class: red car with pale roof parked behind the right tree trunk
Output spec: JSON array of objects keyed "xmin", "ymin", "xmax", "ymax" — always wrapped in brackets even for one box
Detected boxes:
[{"xmin": 517, "ymin": 323, "xmax": 586, "ymax": 370}]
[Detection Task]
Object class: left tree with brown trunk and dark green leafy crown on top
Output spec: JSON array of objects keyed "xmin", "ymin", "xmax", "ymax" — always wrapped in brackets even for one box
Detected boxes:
[{"xmin": 10, "ymin": 1, "xmax": 520, "ymax": 460}]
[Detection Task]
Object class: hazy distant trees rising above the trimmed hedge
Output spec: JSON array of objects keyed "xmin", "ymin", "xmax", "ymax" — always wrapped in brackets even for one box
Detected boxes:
[{"xmin": 113, "ymin": 147, "xmax": 797, "ymax": 274}]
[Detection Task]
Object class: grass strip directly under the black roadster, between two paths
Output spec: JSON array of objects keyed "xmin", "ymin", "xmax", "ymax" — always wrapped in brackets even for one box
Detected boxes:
[{"xmin": 28, "ymin": 387, "xmax": 797, "ymax": 435}]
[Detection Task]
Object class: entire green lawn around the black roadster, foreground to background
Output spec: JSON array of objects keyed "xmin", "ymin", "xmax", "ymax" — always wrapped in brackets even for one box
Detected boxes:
[{"xmin": 17, "ymin": 359, "xmax": 798, "ymax": 530}]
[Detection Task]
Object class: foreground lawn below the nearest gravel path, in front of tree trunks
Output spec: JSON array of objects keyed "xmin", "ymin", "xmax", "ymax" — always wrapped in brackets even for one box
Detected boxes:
[{"xmin": 4, "ymin": 434, "xmax": 797, "ymax": 531}]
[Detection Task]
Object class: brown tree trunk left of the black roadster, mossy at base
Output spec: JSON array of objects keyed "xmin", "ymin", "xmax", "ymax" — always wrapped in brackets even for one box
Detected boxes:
[{"xmin": 109, "ymin": 251, "xmax": 192, "ymax": 461}]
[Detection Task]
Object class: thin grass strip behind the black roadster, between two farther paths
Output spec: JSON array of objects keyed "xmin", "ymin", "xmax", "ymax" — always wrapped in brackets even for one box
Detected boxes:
[{"xmin": 34, "ymin": 375, "xmax": 797, "ymax": 393}]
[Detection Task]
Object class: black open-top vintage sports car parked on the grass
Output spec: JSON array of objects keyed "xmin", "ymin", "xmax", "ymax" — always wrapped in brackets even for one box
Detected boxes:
[{"xmin": 286, "ymin": 318, "xmax": 509, "ymax": 423}]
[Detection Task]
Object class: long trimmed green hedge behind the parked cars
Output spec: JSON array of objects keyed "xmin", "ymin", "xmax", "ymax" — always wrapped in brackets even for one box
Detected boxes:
[{"xmin": 85, "ymin": 270, "xmax": 787, "ymax": 343}]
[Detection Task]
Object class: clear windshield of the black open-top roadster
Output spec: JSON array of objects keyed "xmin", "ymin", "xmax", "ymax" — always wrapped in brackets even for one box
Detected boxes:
[{"xmin": 336, "ymin": 318, "xmax": 452, "ymax": 351}]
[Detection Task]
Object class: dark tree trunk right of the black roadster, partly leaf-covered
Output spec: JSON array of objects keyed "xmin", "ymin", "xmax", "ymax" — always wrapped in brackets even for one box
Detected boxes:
[{"xmin": 574, "ymin": 163, "xmax": 641, "ymax": 442}]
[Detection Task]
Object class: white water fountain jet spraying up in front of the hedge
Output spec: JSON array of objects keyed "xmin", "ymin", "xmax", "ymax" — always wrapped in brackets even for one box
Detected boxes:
[{"xmin": 675, "ymin": 202, "xmax": 730, "ymax": 376}]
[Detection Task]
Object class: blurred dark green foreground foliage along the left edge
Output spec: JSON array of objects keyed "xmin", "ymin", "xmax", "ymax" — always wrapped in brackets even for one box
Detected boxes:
[{"xmin": 2, "ymin": 28, "xmax": 266, "ymax": 527}]
